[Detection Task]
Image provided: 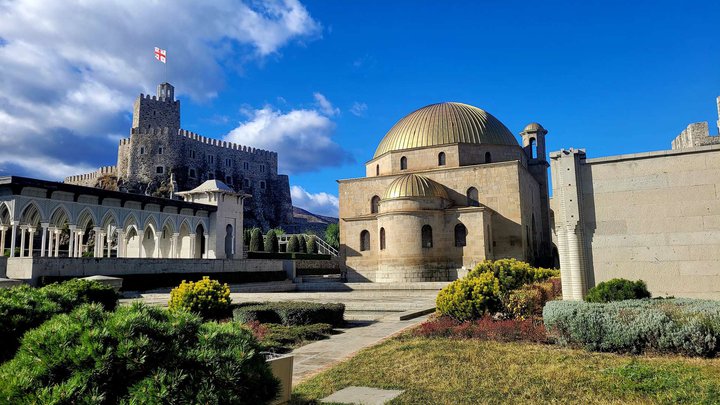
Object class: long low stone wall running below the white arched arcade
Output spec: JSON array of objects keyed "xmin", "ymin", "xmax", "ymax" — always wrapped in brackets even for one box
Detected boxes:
[{"xmin": 7, "ymin": 257, "xmax": 287, "ymax": 284}]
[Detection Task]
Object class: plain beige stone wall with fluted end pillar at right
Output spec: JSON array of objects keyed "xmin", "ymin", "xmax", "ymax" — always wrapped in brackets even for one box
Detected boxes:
[{"xmin": 552, "ymin": 146, "xmax": 720, "ymax": 299}]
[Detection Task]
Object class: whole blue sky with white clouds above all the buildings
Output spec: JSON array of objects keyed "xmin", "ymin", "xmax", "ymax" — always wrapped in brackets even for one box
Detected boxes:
[{"xmin": 0, "ymin": 0, "xmax": 720, "ymax": 214}]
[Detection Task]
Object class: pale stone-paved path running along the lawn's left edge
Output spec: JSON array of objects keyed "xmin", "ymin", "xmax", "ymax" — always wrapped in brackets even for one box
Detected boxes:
[{"xmin": 292, "ymin": 315, "xmax": 428, "ymax": 385}]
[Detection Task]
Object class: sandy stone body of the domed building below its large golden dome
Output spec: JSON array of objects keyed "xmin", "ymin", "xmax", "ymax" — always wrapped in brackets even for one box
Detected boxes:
[{"xmin": 339, "ymin": 102, "xmax": 552, "ymax": 282}]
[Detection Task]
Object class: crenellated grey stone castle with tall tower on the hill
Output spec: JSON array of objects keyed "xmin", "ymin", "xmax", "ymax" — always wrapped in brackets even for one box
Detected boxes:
[{"xmin": 65, "ymin": 83, "xmax": 293, "ymax": 229}]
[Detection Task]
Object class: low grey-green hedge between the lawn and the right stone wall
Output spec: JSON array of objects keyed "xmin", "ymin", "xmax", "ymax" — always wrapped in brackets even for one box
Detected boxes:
[{"xmin": 543, "ymin": 299, "xmax": 720, "ymax": 357}]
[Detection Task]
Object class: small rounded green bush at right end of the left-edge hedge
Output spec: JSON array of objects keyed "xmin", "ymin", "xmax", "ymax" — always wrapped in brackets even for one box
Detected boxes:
[{"xmin": 40, "ymin": 279, "xmax": 120, "ymax": 311}]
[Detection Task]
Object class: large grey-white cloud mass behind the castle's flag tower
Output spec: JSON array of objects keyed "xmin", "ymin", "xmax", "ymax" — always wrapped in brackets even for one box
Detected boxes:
[{"xmin": 0, "ymin": 0, "xmax": 321, "ymax": 179}]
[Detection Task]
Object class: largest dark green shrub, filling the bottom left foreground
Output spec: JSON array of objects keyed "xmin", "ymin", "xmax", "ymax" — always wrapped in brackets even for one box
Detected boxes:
[{"xmin": 0, "ymin": 304, "xmax": 279, "ymax": 404}]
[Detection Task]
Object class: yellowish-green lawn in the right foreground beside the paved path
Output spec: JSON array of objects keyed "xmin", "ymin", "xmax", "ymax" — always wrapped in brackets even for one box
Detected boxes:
[{"xmin": 292, "ymin": 336, "xmax": 720, "ymax": 404}]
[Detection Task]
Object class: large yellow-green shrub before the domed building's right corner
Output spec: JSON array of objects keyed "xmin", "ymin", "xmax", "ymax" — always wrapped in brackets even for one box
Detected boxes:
[{"xmin": 436, "ymin": 259, "xmax": 560, "ymax": 321}]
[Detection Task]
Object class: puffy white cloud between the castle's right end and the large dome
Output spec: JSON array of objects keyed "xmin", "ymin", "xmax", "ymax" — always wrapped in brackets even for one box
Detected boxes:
[{"xmin": 225, "ymin": 105, "xmax": 353, "ymax": 174}]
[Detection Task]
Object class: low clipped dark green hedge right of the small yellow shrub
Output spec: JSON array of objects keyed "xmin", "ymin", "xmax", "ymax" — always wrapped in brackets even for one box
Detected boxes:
[{"xmin": 233, "ymin": 301, "xmax": 345, "ymax": 326}]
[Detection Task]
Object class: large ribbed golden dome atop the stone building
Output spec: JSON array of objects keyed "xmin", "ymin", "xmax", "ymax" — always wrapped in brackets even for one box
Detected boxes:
[{"xmin": 374, "ymin": 103, "xmax": 518, "ymax": 158}]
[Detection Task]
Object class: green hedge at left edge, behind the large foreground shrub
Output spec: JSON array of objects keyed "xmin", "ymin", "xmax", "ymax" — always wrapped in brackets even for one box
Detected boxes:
[{"xmin": 0, "ymin": 279, "xmax": 118, "ymax": 362}]
